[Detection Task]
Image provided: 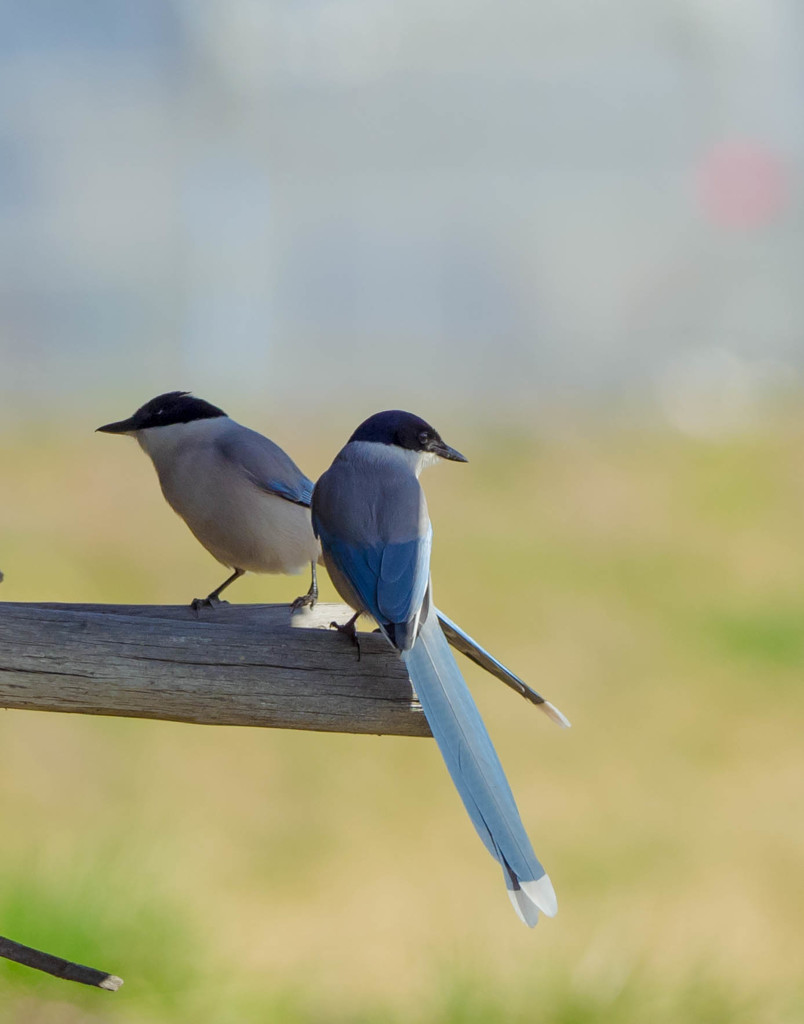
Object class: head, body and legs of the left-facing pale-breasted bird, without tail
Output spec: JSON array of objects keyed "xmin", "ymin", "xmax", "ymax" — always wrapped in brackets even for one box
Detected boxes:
[{"xmin": 97, "ymin": 391, "xmax": 321, "ymax": 610}]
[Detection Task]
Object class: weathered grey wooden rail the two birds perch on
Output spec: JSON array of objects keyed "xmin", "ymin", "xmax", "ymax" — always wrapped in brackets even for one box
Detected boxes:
[{"xmin": 0, "ymin": 603, "xmax": 430, "ymax": 736}]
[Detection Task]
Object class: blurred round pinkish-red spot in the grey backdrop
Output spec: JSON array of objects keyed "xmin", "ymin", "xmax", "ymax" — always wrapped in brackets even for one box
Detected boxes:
[{"xmin": 696, "ymin": 139, "xmax": 788, "ymax": 228}]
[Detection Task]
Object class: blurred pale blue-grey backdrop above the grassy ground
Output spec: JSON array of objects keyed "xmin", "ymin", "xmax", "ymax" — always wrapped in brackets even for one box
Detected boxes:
[{"xmin": 0, "ymin": 0, "xmax": 804, "ymax": 431}]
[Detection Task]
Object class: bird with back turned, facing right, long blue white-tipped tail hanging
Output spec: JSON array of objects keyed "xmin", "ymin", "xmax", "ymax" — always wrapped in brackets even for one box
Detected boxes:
[{"xmin": 312, "ymin": 410, "xmax": 557, "ymax": 928}]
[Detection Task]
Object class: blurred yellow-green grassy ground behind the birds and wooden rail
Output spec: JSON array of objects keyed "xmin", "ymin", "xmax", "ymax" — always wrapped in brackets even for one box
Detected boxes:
[{"xmin": 0, "ymin": 412, "xmax": 804, "ymax": 1024}]
